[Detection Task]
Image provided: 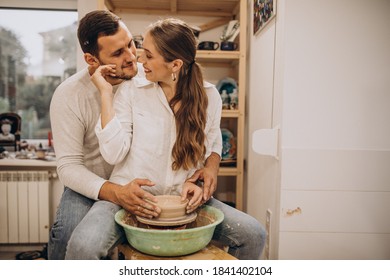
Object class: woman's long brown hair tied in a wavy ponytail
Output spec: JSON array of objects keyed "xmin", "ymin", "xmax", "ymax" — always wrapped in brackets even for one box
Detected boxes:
[{"xmin": 148, "ymin": 18, "xmax": 208, "ymax": 170}]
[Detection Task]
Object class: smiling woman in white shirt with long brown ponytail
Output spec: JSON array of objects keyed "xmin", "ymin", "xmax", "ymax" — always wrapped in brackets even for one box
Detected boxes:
[{"xmin": 92, "ymin": 19, "xmax": 222, "ymax": 218}]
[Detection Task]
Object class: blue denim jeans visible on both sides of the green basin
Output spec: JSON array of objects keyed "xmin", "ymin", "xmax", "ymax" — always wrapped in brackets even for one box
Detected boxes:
[{"xmin": 48, "ymin": 187, "xmax": 266, "ymax": 260}]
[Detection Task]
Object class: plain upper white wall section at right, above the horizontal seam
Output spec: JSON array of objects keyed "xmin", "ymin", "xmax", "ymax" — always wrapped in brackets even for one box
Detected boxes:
[{"xmin": 283, "ymin": 0, "xmax": 390, "ymax": 150}]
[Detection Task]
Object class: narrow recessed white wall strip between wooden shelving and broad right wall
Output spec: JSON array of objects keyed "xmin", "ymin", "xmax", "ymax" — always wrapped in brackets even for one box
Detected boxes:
[{"xmin": 246, "ymin": 1, "xmax": 283, "ymax": 259}]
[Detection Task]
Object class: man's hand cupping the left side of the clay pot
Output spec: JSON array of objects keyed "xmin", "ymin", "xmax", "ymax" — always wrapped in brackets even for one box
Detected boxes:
[{"xmin": 99, "ymin": 179, "xmax": 161, "ymax": 219}]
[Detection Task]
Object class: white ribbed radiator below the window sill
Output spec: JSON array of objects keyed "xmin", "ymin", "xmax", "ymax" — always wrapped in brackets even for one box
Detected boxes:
[{"xmin": 0, "ymin": 171, "xmax": 50, "ymax": 244}]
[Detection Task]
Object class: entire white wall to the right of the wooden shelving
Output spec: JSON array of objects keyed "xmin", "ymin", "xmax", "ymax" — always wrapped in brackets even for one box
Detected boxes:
[{"xmin": 248, "ymin": 0, "xmax": 390, "ymax": 259}]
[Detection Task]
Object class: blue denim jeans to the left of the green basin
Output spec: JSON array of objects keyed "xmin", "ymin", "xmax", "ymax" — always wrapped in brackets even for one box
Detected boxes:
[{"xmin": 48, "ymin": 187, "xmax": 125, "ymax": 260}]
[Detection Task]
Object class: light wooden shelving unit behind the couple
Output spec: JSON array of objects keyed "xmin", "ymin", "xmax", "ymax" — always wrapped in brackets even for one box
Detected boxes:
[{"xmin": 105, "ymin": 0, "xmax": 247, "ymax": 210}]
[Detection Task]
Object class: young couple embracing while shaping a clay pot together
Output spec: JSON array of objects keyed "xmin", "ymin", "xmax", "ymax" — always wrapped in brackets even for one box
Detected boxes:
[{"xmin": 48, "ymin": 11, "xmax": 266, "ymax": 259}]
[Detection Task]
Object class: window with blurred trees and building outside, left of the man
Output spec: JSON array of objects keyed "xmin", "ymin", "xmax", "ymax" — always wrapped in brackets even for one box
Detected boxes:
[{"xmin": 0, "ymin": 8, "xmax": 77, "ymax": 139}]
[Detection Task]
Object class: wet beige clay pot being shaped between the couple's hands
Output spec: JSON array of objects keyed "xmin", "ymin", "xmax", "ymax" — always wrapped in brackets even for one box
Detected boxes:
[{"xmin": 152, "ymin": 195, "xmax": 188, "ymax": 220}]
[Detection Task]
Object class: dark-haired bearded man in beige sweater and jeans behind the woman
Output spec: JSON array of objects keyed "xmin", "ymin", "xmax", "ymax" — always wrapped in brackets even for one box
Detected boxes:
[{"xmin": 48, "ymin": 11, "xmax": 264, "ymax": 259}]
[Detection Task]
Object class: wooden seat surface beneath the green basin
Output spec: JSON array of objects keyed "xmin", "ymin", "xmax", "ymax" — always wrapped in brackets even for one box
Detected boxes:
[{"xmin": 118, "ymin": 243, "xmax": 237, "ymax": 260}]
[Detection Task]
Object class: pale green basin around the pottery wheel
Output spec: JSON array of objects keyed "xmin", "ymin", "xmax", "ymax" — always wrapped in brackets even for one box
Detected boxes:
[{"xmin": 115, "ymin": 205, "xmax": 224, "ymax": 257}]
